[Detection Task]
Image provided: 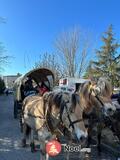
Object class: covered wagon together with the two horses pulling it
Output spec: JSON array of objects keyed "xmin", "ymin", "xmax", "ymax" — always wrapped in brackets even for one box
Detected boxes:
[{"xmin": 14, "ymin": 71, "xmax": 120, "ymax": 159}]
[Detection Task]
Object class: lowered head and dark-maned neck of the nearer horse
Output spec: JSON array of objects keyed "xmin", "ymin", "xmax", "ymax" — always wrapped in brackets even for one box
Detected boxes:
[{"xmin": 50, "ymin": 92, "xmax": 87, "ymax": 142}]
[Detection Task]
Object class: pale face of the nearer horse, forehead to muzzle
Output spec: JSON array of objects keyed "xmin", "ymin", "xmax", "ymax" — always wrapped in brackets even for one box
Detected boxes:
[{"xmin": 63, "ymin": 94, "xmax": 87, "ymax": 140}]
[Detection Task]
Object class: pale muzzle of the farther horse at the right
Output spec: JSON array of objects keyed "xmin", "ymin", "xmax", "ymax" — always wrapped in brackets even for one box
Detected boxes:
[{"xmin": 104, "ymin": 103, "xmax": 116, "ymax": 116}]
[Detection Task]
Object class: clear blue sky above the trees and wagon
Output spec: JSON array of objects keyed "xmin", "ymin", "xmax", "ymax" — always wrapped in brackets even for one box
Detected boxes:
[{"xmin": 0, "ymin": 0, "xmax": 120, "ymax": 75}]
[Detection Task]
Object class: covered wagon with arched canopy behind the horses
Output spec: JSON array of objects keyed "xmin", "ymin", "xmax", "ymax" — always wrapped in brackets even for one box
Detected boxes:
[{"xmin": 14, "ymin": 68, "xmax": 54, "ymax": 118}]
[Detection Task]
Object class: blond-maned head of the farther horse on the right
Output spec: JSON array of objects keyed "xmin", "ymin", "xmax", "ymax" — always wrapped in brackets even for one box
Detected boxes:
[{"xmin": 80, "ymin": 78, "xmax": 116, "ymax": 116}]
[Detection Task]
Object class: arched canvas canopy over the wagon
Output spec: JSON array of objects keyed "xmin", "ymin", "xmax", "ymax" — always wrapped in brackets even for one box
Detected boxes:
[{"xmin": 14, "ymin": 68, "xmax": 54, "ymax": 101}]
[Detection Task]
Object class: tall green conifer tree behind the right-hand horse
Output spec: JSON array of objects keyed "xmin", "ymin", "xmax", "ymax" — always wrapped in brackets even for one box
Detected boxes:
[{"xmin": 86, "ymin": 25, "xmax": 120, "ymax": 86}]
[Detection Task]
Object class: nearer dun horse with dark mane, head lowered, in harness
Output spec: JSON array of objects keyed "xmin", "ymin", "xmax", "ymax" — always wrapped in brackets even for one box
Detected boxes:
[{"xmin": 22, "ymin": 92, "xmax": 87, "ymax": 159}]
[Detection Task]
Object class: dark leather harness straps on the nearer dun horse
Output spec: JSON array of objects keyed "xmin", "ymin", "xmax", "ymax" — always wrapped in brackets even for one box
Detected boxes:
[{"xmin": 22, "ymin": 94, "xmax": 83, "ymax": 139}]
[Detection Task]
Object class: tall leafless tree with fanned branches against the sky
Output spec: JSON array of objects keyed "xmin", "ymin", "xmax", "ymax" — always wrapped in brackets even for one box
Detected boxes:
[{"xmin": 55, "ymin": 28, "xmax": 93, "ymax": 77}]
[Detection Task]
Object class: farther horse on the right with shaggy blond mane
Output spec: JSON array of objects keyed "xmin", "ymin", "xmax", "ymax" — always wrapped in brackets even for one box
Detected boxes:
[{"xmin": 80, "ymin": 78, "xmax": 116, "ymax": 150}]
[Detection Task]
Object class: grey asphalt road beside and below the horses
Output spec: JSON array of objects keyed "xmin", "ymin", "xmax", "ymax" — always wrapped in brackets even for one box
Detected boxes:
[{"xmin": 0, "ymin": 95, "xmax": 116, "ymax": 160}]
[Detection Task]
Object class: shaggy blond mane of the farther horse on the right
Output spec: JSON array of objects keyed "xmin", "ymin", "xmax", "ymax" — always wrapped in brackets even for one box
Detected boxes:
[{"xmin": 79, "ymin": 77, "xmax": 112, "ymax": 112}]
